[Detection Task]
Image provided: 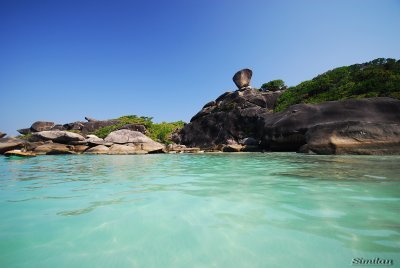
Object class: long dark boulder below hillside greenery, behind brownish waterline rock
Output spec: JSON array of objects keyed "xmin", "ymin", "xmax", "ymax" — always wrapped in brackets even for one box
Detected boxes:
[{"xmin": 259, "ymin": 97, "xmax": 400, "ymax": 151}]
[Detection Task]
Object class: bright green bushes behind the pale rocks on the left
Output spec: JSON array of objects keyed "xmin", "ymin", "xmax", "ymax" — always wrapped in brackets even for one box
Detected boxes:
[{"xmin": 93, "ymin": 115, "xmax": 185, "ymax": 144}]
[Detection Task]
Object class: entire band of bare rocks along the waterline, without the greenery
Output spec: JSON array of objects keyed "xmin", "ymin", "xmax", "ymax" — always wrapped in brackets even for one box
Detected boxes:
[{"xmin": 0, "ymin": 69, "xmax": 400, "ymax": 156}]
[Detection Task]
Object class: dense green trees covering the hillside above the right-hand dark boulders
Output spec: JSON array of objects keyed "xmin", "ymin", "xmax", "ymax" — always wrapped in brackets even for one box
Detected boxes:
[{"xmin": 275, "ymin": 58, "xmax": 400, "ymax": 111}]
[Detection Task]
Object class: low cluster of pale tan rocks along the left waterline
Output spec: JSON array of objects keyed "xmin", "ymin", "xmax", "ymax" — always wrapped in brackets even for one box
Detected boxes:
[{"xmin": 0, "ymin": 129, "xmax": 200, "ymax": 156}]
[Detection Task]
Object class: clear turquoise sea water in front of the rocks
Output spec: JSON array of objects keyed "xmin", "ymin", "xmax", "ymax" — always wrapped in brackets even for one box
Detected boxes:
[{"xmin": 0, "ymin": 153, "xmax": 400, "ymax": 268}]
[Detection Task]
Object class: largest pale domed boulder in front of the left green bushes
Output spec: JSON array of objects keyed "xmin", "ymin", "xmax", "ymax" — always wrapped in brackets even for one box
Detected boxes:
[{"xmin": 104, "ymin": 129, "xmax": 164, "ymax": 152}]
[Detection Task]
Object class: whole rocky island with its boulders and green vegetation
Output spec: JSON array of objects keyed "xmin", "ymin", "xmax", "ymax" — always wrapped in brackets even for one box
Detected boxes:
[{"xmin": 0, "ymin": 59, "xmax": 400, "ymax": 156}]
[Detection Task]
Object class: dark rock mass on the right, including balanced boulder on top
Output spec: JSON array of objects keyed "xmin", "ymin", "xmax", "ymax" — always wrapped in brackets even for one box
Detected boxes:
[{"xmin": 175, "ymin": 70, "xmax": 400, "ymax": 154}]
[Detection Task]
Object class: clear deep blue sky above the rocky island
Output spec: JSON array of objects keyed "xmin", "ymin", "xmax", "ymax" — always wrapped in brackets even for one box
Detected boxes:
[{"xmin": 0, "ymin": 0, "xmax": 400, "ymax": 135}]
